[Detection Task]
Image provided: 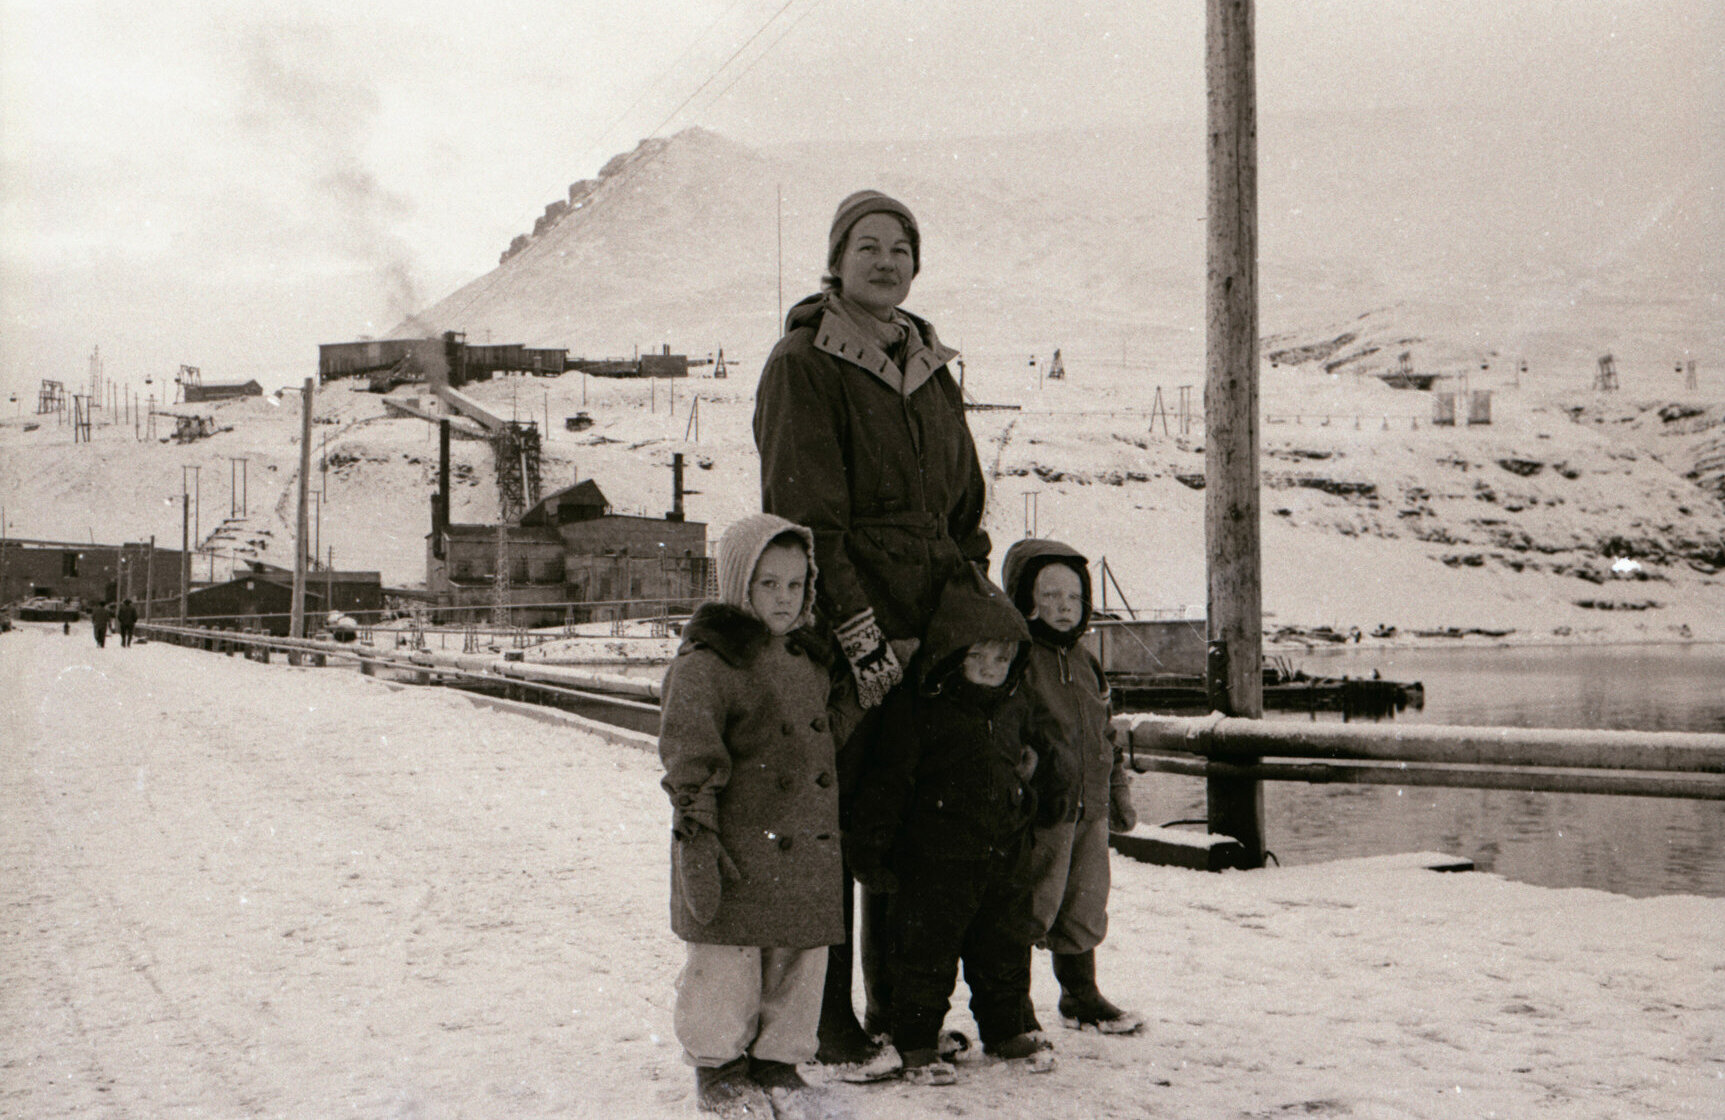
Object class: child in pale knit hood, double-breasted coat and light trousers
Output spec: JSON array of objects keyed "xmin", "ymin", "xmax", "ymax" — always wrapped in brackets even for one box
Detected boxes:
[{"xmin": 659, "ymin": 514, "xmax": 844, "ymax": 1117}]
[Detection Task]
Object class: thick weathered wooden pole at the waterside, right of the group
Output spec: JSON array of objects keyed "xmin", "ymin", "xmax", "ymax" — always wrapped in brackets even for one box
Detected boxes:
[{"xmin": 1204, "ymin": 0, "xmax": 1264, "ymax": 866}]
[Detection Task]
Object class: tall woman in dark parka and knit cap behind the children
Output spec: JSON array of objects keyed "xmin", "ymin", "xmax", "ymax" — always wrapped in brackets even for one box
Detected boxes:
[{"xmin": 754, "ymin": 190, "xmax": 988, "ymax": 1072}]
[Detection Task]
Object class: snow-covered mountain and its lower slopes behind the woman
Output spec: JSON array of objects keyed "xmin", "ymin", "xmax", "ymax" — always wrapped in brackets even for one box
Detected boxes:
[{"xmin": 0, "ymin": 116, "xmax": 1725, "ymax": 639}]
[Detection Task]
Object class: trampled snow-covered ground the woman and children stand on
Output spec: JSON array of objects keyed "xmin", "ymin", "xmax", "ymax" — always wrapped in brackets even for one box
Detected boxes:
[{"xmin": 0, "ymin": 625, "xmax": 1725, "ymax": 1120}]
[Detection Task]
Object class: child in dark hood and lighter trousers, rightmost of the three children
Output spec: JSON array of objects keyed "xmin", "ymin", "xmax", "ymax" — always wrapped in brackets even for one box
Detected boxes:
[{"xmin": 1001, "ymin": 538, "xmax": 1144, "ymax": 1034}]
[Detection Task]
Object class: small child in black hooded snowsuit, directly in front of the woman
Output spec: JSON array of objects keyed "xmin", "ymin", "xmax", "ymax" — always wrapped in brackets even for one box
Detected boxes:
[{"xmin": 845, "ymin": 571, "xmax": 1066, "ymax": 1084}]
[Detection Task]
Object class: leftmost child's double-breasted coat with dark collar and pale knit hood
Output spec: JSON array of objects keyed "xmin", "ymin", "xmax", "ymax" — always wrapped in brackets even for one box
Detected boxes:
[{"xmin": 659, "ymin": 514, "xmax": 844, "ymax": 949}]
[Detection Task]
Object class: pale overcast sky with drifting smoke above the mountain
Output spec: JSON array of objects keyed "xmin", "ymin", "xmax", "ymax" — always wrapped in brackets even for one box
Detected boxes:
[{"xmin": 0, "ymin": 0, "xmax": 1725, "ymax": 399}]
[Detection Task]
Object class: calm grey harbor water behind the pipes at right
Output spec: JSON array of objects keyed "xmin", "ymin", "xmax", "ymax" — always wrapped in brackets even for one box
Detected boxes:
[{"xmin": 1133, "ymin": 645, "xmax": 1725, "ymax": 897}]
